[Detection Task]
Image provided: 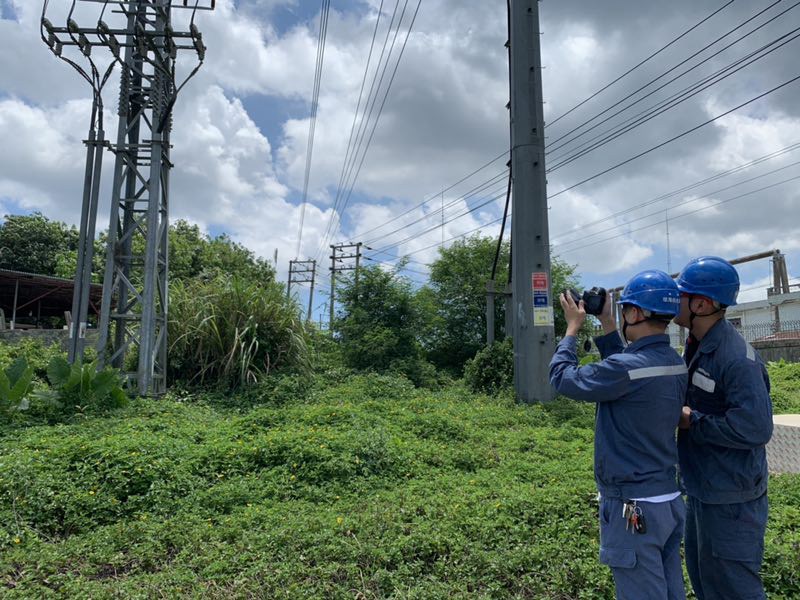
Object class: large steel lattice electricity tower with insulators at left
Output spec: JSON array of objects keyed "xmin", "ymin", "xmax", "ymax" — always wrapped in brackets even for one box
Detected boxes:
[{"xmin": 42, "ymin": 0, "xmax": 215, "ymax": 395}]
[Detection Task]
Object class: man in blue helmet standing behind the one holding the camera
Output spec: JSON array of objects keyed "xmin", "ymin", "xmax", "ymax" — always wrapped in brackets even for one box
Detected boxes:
[{"xmin": 675, "ymin": 256, "xmax": 772, "ymax": 600}]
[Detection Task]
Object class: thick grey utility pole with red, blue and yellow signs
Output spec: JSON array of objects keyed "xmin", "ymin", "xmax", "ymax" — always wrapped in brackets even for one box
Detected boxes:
[{"xmin": 509, "ymin": 0, "xmax": 555, "ymax": 402}]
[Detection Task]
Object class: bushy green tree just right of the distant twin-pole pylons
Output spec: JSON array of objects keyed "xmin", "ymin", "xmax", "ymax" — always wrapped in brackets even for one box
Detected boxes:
[{"xmin": 336, "ymin": 266, "xmax": 435, "ymax": 385}]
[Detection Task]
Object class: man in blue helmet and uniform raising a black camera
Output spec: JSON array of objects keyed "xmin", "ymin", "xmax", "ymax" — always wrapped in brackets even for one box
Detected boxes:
[{"xmin": 550, "ymin": 271, "xmax": 687, "ymax": 600}]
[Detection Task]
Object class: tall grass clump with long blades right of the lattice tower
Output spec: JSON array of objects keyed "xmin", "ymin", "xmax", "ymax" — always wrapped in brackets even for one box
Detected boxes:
[{"xmin": 168, "ymin": 276, "xmax": 310, "ymax": 388}]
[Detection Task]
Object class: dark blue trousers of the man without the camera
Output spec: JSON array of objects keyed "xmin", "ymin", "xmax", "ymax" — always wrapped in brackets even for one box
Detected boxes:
[{"xmin": 685, "ymin": 494, "xmax": 769, "ymax": 600}]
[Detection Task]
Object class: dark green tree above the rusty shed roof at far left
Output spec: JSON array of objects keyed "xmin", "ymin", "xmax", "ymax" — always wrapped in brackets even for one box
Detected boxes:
[{"xmin": 0, "ymin": 212, "xmax": 78, "ymax": 276}]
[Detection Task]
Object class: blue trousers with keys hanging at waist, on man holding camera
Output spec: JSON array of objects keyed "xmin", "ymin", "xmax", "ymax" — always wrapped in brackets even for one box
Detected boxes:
[{"xmin": 600, "ymin": 496, "xmax": 686, "ymax": 600}]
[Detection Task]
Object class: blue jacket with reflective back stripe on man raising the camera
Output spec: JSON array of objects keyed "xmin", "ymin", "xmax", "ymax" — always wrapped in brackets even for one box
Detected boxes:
[{"xmin": 550, "ymin": 331, "xmax": 687, "ymax": 499}]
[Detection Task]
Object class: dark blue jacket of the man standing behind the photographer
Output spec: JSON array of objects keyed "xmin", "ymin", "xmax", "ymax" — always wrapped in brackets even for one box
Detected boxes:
[{"xmin": 678, "ymin": 319, "xmax": 772, "ymax": 504}]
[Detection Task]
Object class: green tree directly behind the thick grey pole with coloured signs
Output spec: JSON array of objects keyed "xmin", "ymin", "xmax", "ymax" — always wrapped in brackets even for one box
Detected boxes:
[{"xmin": 418, "ymin": 235, "xmax": 577, "ymax": 374}]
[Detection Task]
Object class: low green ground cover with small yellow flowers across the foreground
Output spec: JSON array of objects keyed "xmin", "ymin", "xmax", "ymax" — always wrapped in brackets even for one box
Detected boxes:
[{"xmin": 0, "ymin": 366, "xmax": 800, "ymax": 599}]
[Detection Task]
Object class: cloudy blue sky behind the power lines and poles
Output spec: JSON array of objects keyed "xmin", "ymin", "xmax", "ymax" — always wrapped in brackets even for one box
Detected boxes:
[{"xmin": 0, "ymin": 0, "xmax": 800, "ymax": 318}]
